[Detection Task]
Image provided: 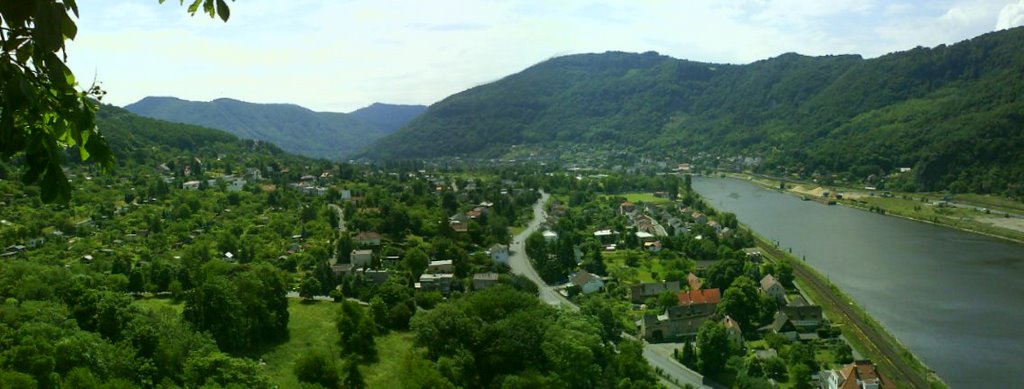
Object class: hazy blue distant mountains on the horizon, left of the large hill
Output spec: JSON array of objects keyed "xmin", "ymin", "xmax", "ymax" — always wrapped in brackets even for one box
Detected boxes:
[{"xmin": 125, "ymin": 97, "xmax": 423, "ymax": 160}]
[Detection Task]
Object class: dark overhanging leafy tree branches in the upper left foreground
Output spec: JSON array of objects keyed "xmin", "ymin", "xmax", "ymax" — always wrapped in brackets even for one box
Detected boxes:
[{"xmin": 0, "ymin": 0, "xmax": 229, "ymax": 203}]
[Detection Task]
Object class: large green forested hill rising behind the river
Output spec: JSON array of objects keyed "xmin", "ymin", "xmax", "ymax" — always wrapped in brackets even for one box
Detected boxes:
[{"xmin": 362, "ymin": 28, "xmax": 1024, "ymax": 192}]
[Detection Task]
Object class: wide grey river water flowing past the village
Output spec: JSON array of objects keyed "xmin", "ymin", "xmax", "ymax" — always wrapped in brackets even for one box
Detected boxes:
[{"xmin": 693, "ymin": 177, "xmax": 1024, "ymax": 388}]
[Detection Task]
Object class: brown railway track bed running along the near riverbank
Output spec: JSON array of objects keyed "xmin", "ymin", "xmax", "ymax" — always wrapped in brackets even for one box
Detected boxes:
[{"xmin": 758, "ymin": 241, "xmax": 929, "ymax": 388}]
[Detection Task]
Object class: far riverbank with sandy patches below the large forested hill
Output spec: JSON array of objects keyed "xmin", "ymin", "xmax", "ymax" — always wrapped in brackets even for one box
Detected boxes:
[{"xmin": 721, "ymin": 173, "xmax": 1024, "ymax": 244}]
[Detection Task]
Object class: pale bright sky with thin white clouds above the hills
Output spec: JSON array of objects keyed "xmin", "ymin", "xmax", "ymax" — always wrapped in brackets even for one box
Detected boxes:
[{"xmin": 68, "ymin": 0, "xmax": 1024, "ymax": 112}]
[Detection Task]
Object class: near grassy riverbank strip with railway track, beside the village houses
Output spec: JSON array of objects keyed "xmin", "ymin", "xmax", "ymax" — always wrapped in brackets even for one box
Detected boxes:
[{"xmin": 744, "ymin": 231, "xmax": 948, "ymax": 388}]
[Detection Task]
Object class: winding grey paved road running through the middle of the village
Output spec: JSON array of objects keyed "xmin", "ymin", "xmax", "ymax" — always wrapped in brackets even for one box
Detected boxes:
[{"xmin": 509, "ymin": 190, "xmax": 707, "ymax": 388}]
